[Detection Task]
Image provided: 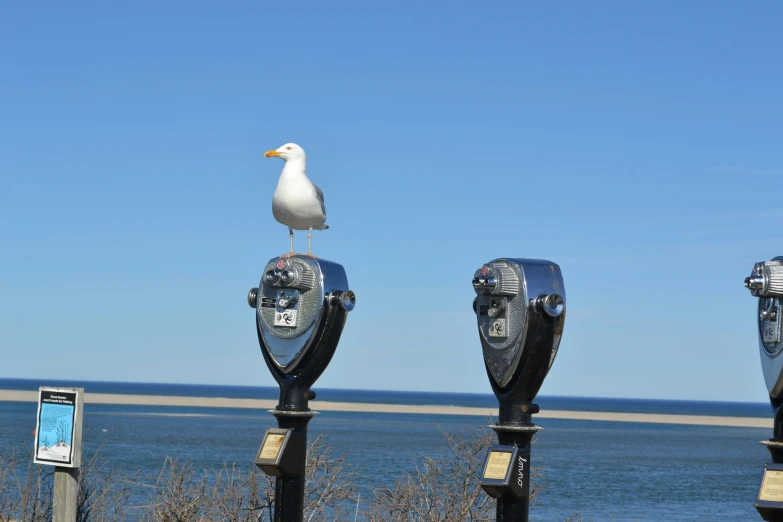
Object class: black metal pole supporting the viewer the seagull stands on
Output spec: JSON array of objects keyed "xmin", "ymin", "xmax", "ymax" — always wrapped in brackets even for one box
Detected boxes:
[{"xmin": 272, "ymin": 410, "xmax": 315, "ymax": 522}]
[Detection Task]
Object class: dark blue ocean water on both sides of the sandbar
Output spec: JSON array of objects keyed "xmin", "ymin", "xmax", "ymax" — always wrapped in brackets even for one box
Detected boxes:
[{"xmin": 0, "ymin": 379, "xmax": 771, "ymax": 522}]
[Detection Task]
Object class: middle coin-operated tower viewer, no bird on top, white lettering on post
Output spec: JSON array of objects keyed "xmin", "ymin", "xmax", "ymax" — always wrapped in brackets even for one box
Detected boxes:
[{"xmin": 473, "ymin": 258, "xmax": 566, "ymax": 522}]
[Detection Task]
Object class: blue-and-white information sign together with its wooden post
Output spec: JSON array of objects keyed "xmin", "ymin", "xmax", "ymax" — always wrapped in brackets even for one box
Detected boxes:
[{"xmin": 33, "ymin": 386, "xmax": 84, "ymax": 522}]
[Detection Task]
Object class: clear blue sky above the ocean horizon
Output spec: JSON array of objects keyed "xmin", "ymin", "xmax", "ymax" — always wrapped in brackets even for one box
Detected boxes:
[{"xmin": 0, "ymin": 1, "xmax": 783, "ymax": 401}]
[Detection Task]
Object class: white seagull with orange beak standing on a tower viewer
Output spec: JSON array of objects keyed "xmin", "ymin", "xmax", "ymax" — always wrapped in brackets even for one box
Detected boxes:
[{"xmin": 264, "ymin": 143, "xmax": 329, "ymax": 258}]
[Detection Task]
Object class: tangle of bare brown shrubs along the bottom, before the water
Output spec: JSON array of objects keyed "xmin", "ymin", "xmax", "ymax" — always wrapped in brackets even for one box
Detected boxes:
[{"xmin": 0, "ymin": 428, "xmax": 564, "ymax": 522}]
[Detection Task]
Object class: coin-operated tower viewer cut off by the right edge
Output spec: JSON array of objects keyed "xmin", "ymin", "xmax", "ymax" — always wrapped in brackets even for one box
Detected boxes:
[{"xmin": 745, "ymin": 257, "xmax": 783, "ymax": 522}]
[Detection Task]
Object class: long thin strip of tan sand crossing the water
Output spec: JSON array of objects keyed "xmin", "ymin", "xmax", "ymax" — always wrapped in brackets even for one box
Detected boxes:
[{"xmin": 0, "ymin": 390, "xmax": 772, "ymax": 429}]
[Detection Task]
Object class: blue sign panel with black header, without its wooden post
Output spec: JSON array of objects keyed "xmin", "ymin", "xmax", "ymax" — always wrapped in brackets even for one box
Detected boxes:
[{"xmin": 33, "ymin": 387, "xmax": 82, "ymax": 468}]
